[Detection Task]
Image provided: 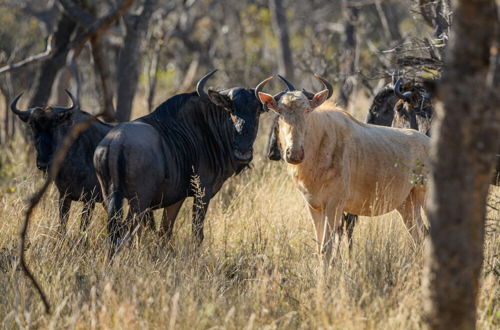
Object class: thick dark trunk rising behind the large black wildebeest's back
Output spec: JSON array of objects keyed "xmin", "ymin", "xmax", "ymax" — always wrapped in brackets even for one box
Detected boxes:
[{"xmin": 116, "ymin": 0, "xmax": 158, "ymax": 121}]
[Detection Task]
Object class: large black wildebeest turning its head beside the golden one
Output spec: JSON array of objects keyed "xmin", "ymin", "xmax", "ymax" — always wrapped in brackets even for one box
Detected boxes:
[{"xmin": 94, "ymin": 70, "xmax": 263, "ymax": 253}]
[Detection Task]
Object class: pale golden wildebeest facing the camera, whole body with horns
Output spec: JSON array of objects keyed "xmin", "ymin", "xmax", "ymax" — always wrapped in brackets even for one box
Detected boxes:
[{"xmin": 255, "ymin": 75, "xmax": 429, "ymax": 260}]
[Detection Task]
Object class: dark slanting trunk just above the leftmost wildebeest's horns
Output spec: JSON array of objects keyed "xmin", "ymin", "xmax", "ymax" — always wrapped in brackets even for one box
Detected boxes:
[{"xmin": 30, "ymin": 14, "xmax": 76, "ymax": 106}]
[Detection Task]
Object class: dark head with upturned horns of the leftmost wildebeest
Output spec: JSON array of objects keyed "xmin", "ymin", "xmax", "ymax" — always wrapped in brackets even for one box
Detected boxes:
[{"xmin": 10, "ymin": 91, "xmax": 77, "ymax": 171}]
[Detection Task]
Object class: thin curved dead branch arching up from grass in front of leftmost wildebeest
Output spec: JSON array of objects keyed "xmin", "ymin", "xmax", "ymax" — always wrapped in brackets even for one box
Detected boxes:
[{"xmin": 19, "ymin": 110, "xmax": 101, "ymax": 314}]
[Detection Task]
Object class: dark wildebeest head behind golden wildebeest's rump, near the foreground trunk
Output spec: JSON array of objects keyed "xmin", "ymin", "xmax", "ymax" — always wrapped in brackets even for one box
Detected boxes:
[{"xmin": 391, "ymin": 78, "xmax": 433, "ymax": 135}]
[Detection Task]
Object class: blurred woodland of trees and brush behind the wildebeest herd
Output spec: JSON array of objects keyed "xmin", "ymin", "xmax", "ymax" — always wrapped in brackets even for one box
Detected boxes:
[{"xmin": 0, "ymin": 0, "xmax": 450, "ymax": 144}]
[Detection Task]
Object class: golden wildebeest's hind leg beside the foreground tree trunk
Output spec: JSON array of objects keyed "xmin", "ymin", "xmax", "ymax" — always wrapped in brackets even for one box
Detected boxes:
[{"xmin": 397, "ymin": 187, "xmax": 425, "ymax": 244}]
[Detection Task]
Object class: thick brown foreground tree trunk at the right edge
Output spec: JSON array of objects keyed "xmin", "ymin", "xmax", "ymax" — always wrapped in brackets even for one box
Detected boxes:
[{"xmin": 424, "ymin": 0, "xmax": 500, "ymax": 329}]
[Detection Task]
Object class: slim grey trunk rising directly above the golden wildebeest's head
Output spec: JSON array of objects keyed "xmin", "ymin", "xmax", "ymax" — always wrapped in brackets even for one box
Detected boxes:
[{"xmin": 269, "ymin": 0, "xmax": 294, "ymax": 81}]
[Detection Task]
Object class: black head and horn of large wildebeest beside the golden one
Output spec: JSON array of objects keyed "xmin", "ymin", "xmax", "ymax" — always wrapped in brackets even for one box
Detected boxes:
[{"xmin": 196, "ymin": 70, "xmax": 264, "ymax": 163}]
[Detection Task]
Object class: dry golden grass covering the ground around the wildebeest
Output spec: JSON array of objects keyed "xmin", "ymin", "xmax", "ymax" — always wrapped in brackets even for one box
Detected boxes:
[{"xmin": 0, "ymin": 99, "xmax": 500, "ymax": 329}]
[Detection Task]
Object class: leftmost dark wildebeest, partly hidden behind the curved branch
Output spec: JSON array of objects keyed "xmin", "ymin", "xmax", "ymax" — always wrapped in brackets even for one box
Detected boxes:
[{"xmin": 10, "ymin": 91, "xmax": 113, "ymax": 232}]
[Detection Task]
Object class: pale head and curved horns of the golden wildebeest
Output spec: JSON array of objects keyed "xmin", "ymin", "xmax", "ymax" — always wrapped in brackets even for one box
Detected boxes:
[{"xmin": 256, "ymin": 74, "xmax": 333, "ymax": 164}]
